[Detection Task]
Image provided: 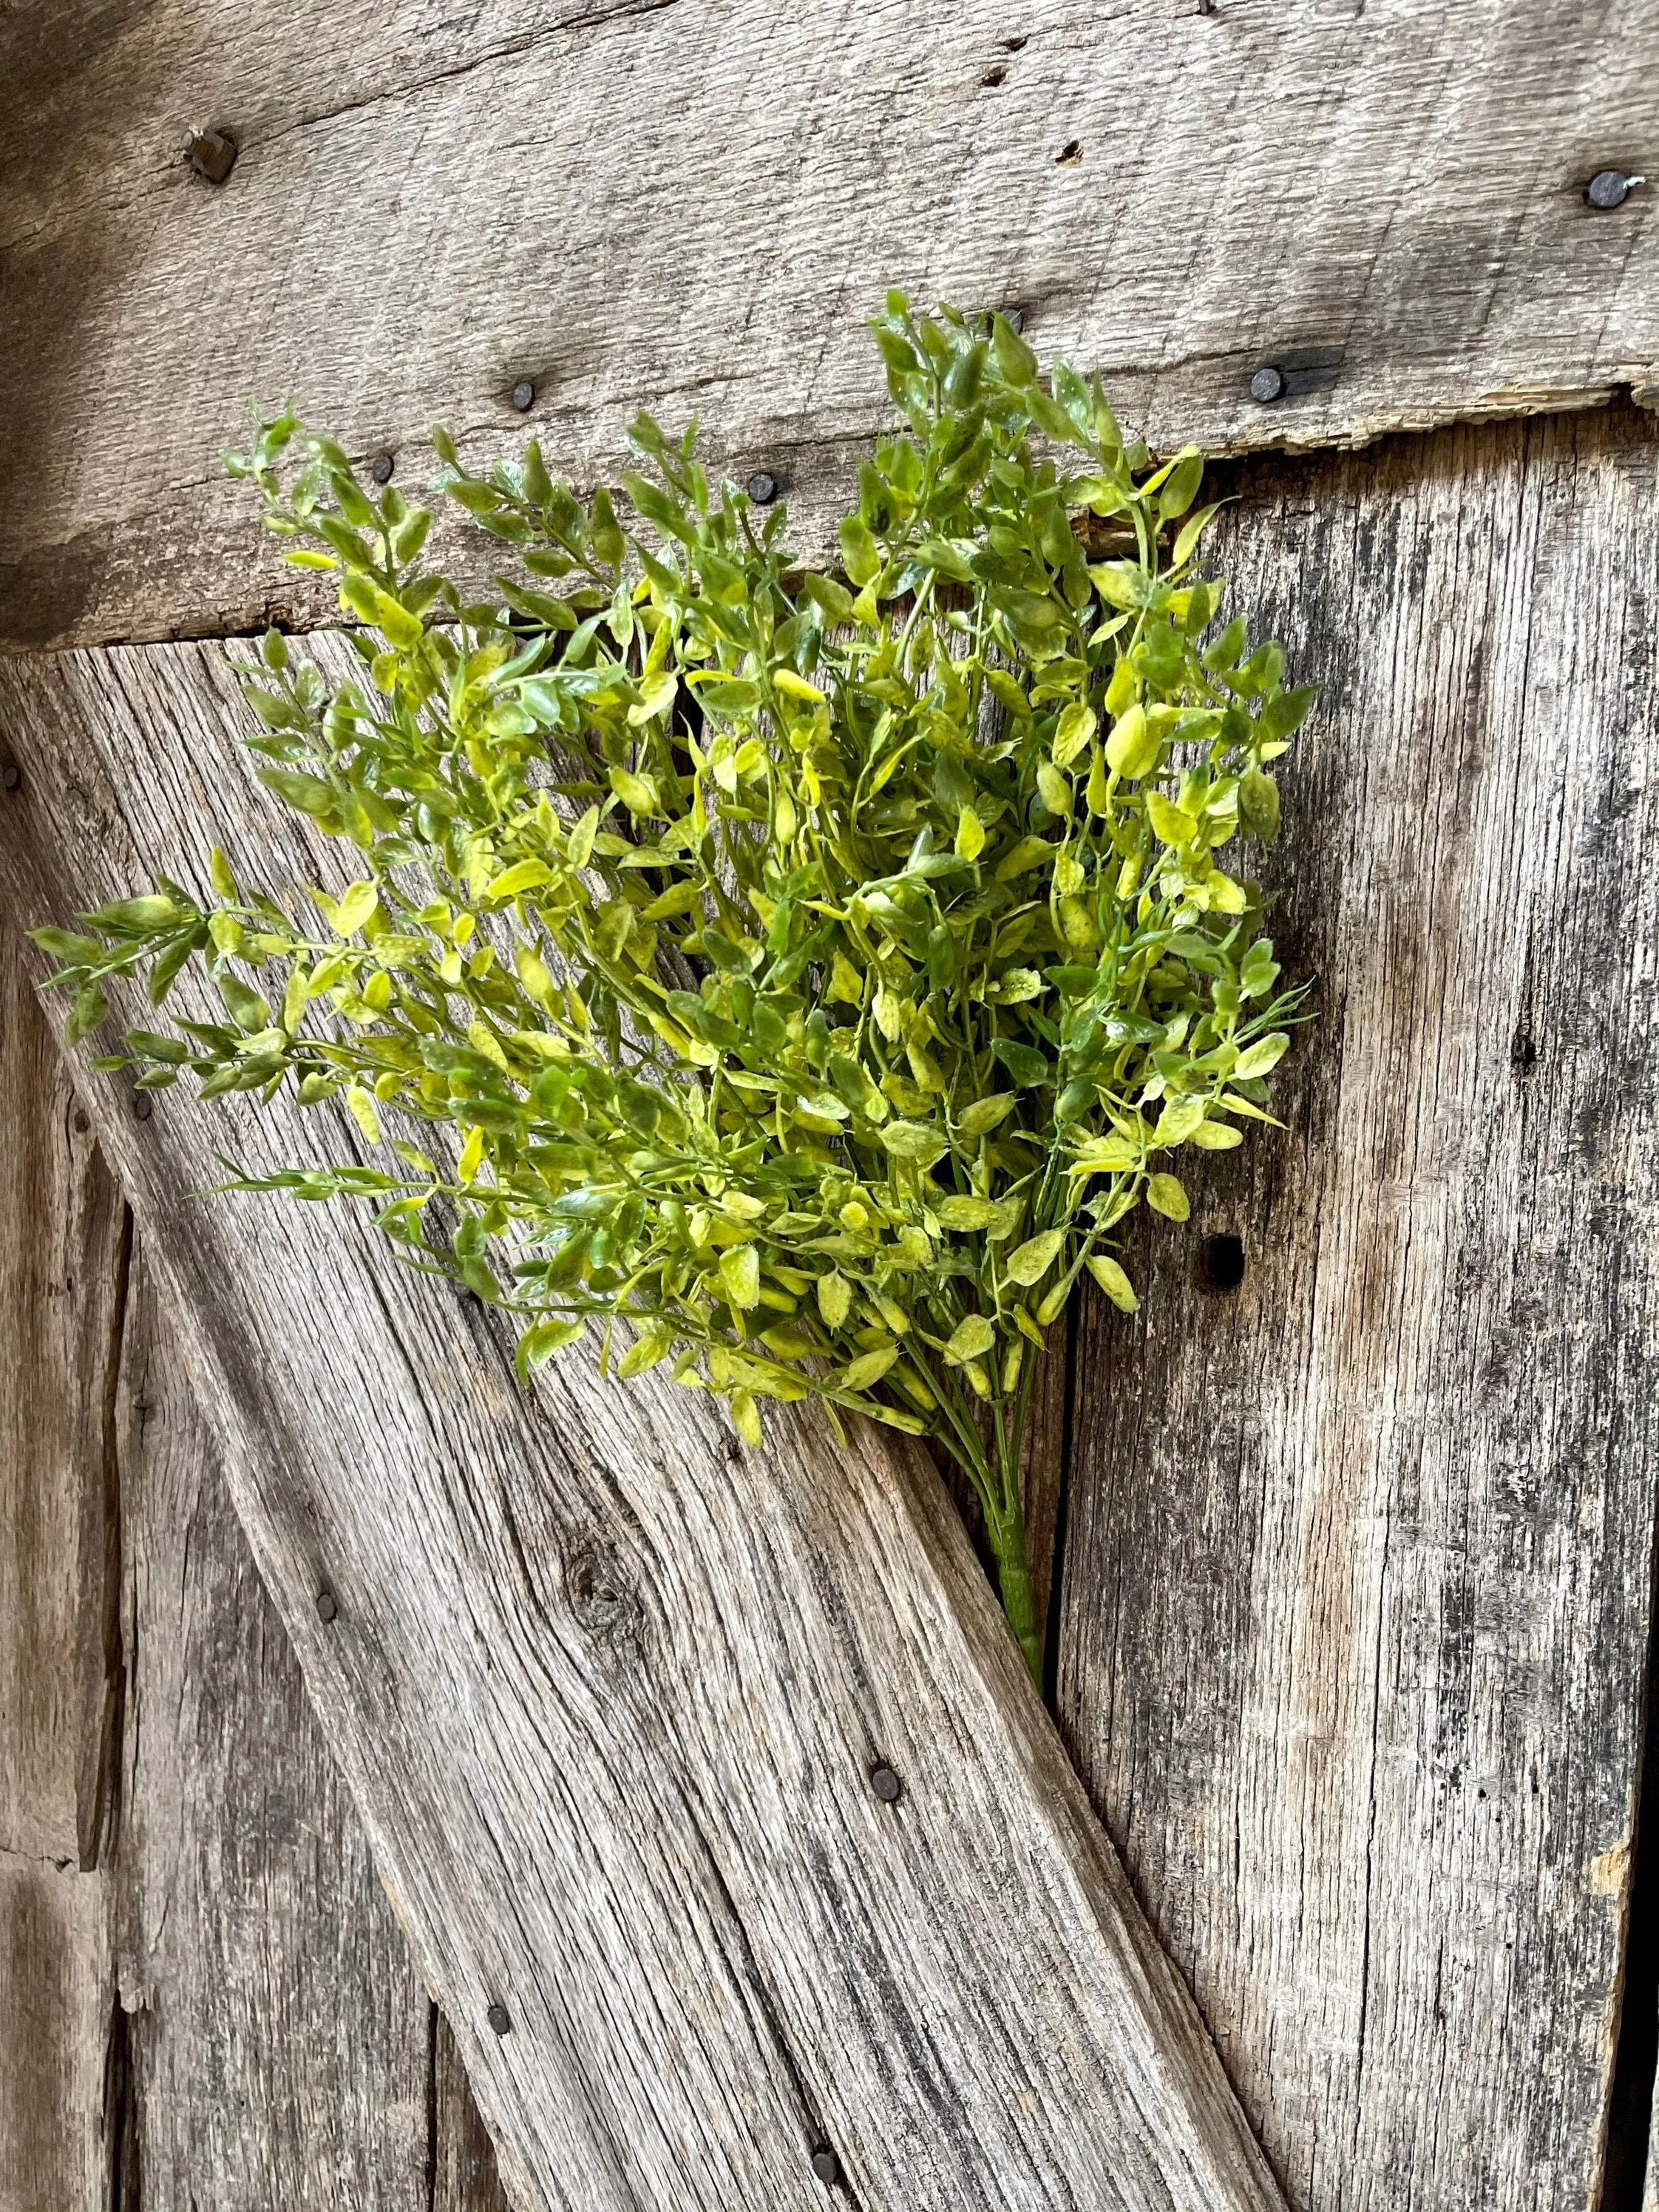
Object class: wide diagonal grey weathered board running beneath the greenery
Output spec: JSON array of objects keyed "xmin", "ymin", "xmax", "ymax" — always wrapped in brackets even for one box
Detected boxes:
[{"xmin": 0, "ymin": 648, "xmax": 1276, "ymax": 2212}]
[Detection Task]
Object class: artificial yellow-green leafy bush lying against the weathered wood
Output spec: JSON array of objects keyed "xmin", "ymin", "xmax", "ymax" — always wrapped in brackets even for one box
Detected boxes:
[{"xmin": 38, "ymin": 294, "xmax": 1309, "ymax": 1672}]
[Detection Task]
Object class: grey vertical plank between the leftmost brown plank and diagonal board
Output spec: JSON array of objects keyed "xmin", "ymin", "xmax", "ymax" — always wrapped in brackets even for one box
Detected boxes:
[{"xmin": 115, "ymin": 1256, "xmax": 442, "ymax": 2212}]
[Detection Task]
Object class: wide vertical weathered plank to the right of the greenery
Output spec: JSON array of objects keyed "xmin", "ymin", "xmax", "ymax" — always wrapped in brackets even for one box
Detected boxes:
[{"xmin": 1059, "ymin": 414, "xmax": 1659, "ymax": 2212}]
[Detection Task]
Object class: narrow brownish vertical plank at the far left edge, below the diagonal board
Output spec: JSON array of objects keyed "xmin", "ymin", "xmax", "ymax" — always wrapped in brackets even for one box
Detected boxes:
[{"xmin": 0, "ymin": 947, "xmax": 126, "ymax": 2212}]
